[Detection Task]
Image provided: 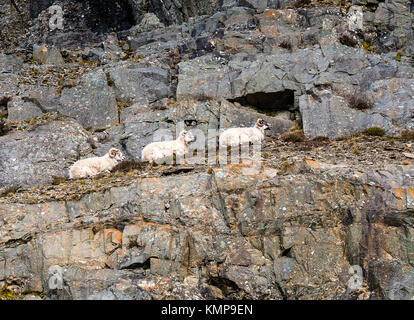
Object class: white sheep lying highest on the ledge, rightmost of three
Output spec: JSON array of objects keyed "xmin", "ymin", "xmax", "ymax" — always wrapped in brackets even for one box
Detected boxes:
[{"xmin": 219, "ymin": 119, "xmax": 270, "ymax": 146}]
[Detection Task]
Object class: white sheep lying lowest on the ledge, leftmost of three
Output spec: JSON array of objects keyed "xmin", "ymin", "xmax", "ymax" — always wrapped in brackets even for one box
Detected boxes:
[{"xmin": 69, "ymin": 148, "xmax": 125, "ymax": 179}]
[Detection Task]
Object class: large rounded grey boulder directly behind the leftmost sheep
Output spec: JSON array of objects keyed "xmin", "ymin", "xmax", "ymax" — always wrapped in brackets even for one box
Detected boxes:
[{"xmin": 0, "ymin": 121, "xmax": 91, "ymax": 187}]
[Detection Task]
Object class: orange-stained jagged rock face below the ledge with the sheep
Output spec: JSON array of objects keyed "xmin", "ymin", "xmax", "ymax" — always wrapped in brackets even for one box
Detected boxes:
[{"xmin": 0, "ymin": 159, "xmax": 414, "ymax": 299}]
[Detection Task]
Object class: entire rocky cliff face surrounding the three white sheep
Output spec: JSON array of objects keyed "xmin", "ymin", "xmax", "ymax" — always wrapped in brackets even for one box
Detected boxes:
[{"xmin": 0, "ymin": 0, "xmax": 414, "ymax": 300}]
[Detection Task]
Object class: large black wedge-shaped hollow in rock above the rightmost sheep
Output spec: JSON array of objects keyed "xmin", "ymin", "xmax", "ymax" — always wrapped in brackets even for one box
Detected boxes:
[{"xmin": 229, "ymin": 90, "xmax": 296, "ymax": 116}]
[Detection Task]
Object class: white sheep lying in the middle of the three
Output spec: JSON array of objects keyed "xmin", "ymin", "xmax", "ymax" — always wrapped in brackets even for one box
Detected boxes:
[{"xmin": 141, "ymin": 130, "xmax": 196, "ymax": 164}]
